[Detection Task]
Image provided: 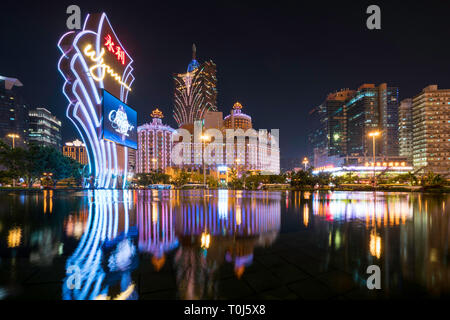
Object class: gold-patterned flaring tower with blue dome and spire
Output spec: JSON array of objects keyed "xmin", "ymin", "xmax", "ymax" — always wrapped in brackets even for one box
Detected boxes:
[{"xmin": 173, "ymin": 44, "xmax": 217, "ymax": 129}]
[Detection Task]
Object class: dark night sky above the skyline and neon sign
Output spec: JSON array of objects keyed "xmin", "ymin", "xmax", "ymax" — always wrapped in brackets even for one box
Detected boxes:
[{"xmin": 0, "ymin": 0, "xmax": 450, "ymax": 158}]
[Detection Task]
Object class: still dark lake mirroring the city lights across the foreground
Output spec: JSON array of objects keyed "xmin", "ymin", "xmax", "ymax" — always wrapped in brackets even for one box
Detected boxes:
[{"xmin": 0, "ymin": 190, "xmax": 450, "ymax": 300}]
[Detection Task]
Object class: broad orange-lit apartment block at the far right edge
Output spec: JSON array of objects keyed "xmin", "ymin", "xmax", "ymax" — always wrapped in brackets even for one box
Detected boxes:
[{"xmin": 412, "ymin": 85, "xmax": 450, "ymax": 175}]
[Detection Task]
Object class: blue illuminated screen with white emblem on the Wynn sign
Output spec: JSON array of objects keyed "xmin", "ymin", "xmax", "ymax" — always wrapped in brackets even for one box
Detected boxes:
[{"xmin": 103, "ymin": 90, "xmax": 137, "ymax": 149}]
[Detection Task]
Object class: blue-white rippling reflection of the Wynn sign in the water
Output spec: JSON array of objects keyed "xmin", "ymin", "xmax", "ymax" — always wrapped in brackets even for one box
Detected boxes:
[{"xmin": 62, "ymin": 190, "xmax": 138, "ymax": 300}]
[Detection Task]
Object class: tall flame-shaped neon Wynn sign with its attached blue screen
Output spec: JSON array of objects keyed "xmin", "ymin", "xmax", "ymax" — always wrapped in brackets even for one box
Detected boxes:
[{"xmin": 58, "ymin": 13, "xmax": 137, "ymax": 188}]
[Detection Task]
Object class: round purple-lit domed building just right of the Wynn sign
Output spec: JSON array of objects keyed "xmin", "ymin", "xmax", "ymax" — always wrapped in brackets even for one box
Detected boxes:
[{"xmin": 136, "ymin": 109, "xmax": 174, "ymax": 173}]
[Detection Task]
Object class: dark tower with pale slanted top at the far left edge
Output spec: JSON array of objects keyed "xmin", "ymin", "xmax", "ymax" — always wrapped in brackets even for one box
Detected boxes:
[{"xmin": 0, "ymin": 76, "xmax": 28, "ymax": 147}]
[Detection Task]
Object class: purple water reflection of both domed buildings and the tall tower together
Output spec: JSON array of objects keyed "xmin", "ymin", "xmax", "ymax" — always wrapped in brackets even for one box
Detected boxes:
[{"xmin": 137, "ymin": 190, "xmax": 281, "ymax": 299}]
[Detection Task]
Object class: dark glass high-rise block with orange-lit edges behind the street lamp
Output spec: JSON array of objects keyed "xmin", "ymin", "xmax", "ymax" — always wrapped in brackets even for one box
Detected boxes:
[{"xmin": 309, "ymin": 83, "xmax": 399, "ymax": 167}]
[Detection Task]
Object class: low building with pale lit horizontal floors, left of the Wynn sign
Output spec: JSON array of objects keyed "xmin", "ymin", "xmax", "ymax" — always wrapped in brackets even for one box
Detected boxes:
[{"xmin": 28, "ymin": 108, "xmax": 61, "ymax": 150}]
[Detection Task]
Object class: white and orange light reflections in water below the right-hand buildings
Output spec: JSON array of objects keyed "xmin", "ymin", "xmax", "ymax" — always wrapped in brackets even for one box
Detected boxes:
[{"xmin": 300, "ymin": 192, "xmax": 450, "ymax": 296}]
